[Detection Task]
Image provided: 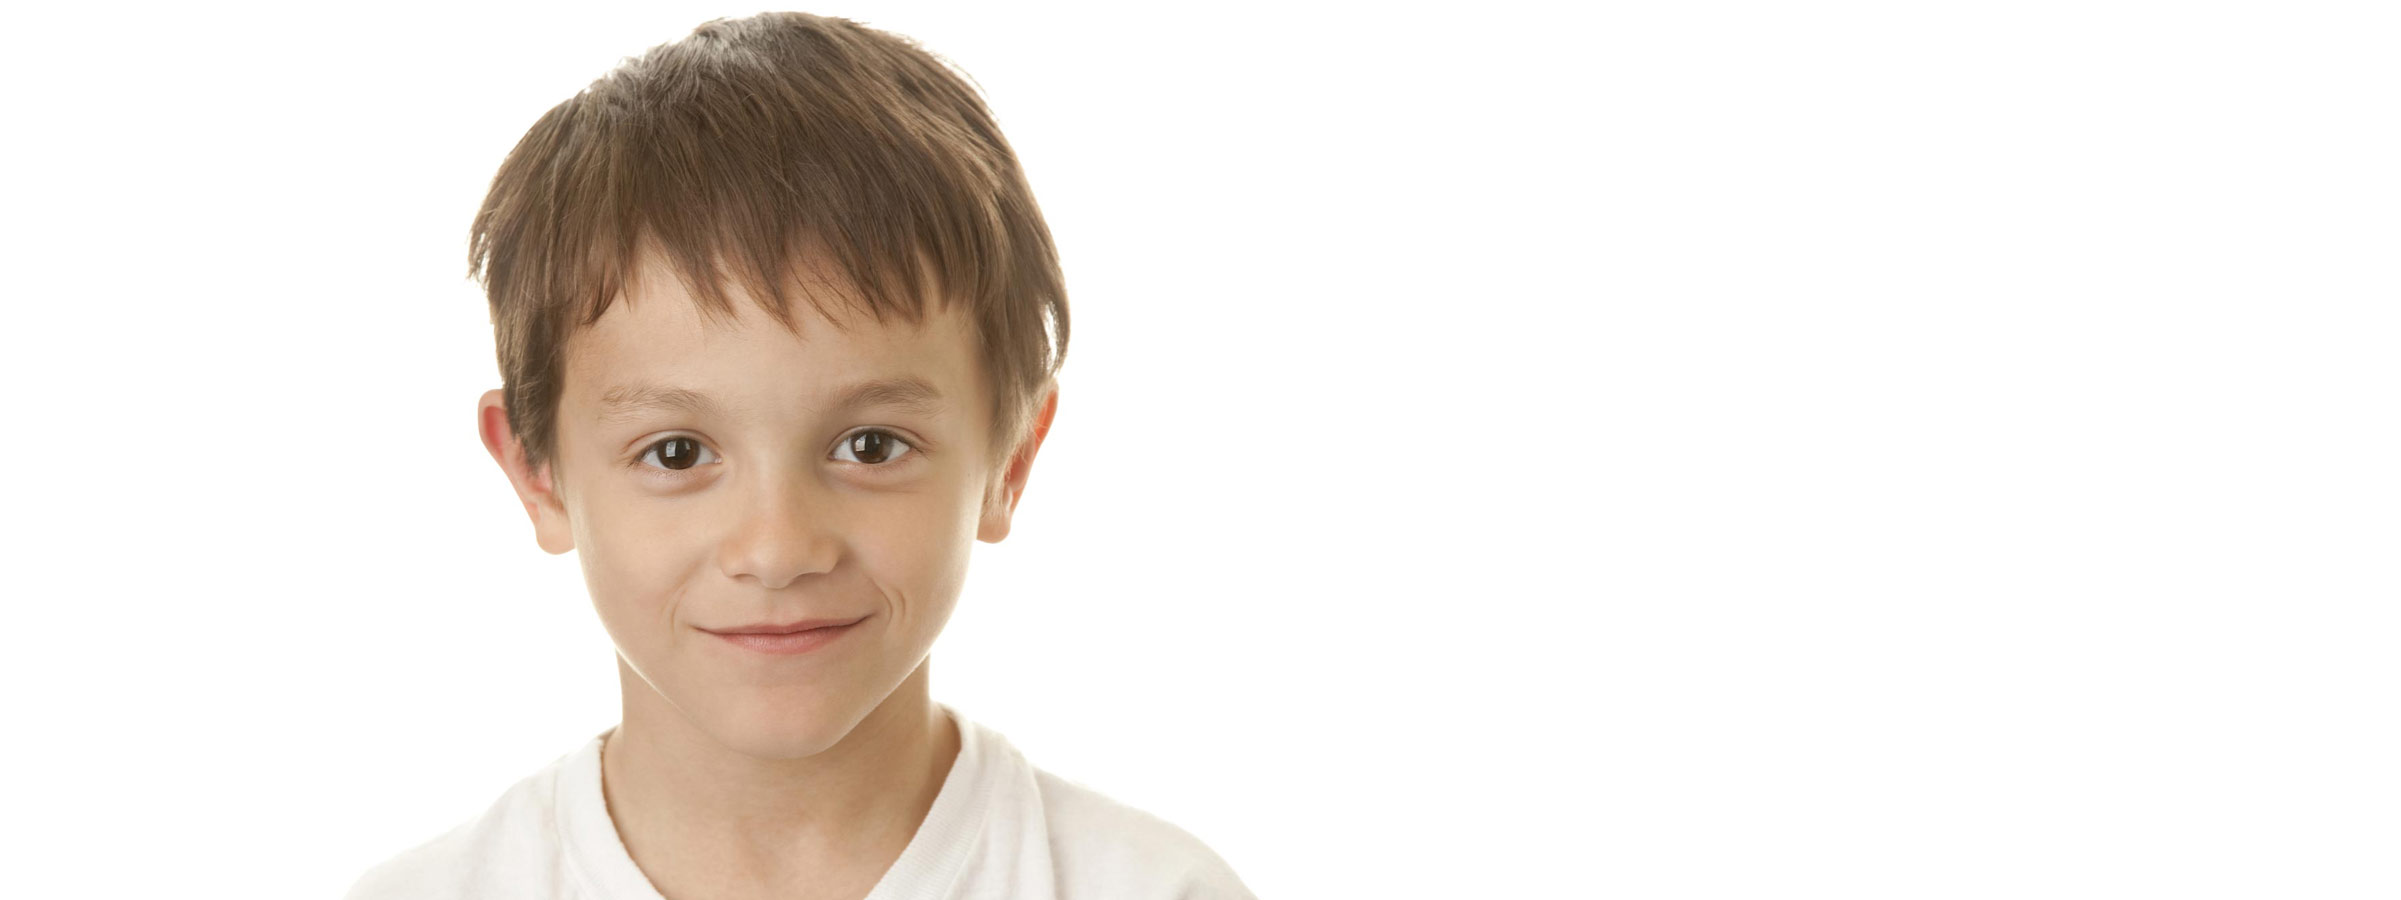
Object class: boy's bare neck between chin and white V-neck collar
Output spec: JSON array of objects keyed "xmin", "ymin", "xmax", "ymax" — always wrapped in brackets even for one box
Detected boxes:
[{"xmin": 600, "ymin": 660, "xmax": 958, "ymax": 895}]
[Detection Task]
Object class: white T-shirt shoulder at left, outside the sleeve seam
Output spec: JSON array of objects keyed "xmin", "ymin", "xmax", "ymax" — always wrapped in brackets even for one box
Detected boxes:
[{"xmin": 343, "ymin": 758, "xmax": 571, "ymax": 900}]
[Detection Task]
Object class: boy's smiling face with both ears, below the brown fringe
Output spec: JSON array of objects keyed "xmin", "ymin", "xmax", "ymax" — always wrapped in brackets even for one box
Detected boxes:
[{"xmin": 483, "ymin": 254, "xmax": 1052, "ymax": 758}]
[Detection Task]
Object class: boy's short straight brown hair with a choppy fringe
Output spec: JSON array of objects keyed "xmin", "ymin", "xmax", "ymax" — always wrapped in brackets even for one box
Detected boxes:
[{"xmin": 468, "ymin": 12, "xmax": 1068, "ymax": 494}]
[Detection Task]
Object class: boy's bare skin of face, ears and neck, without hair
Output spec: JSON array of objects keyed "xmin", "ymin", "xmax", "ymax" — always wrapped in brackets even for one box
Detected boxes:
[{"xmin": 478, "ymin": 250, "xmax": 1059, "ymax": 900}]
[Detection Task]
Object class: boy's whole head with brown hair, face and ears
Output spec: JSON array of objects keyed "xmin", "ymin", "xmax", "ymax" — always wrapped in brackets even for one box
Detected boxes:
[{"xmin": 471, "ymin": 12, "xmax": 1068, "ymax": 758}]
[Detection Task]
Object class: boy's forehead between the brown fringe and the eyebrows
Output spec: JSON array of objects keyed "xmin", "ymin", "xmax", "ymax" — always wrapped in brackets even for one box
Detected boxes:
[{"xmin": 562, "ymin": 256, "xmax": 982, "ymax": 420}]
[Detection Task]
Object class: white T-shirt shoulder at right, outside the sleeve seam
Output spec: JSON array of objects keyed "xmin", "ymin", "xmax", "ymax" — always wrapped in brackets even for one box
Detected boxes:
[{"xmin": 1035, "ymin": 768, "xmax": 1253, "ymax": 900}]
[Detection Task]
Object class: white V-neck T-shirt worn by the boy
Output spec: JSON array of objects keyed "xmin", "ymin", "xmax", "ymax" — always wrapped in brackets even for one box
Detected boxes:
[{"xmin": 348, "ymin": 703, "xmax": 1256, "ymax": 900}]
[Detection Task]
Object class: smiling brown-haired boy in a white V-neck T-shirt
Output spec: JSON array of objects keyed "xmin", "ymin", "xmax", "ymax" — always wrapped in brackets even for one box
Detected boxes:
[{"xmin": 351, "ymin": 14, "xmax": 1249, "ymax": 900}]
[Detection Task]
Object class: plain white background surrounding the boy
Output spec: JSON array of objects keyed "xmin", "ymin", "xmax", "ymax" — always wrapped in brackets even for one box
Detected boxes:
[{"xmin": 0, "ymin": 0, "xmax": 2401, "ymax": 898}]
